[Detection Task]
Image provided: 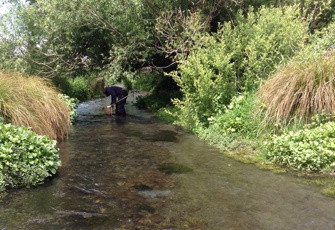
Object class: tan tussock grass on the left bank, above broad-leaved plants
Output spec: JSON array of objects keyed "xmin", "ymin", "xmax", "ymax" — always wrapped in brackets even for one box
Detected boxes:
[{"xmin": 0, "ymin": 72, "xmax": 70, "ymax": 139}]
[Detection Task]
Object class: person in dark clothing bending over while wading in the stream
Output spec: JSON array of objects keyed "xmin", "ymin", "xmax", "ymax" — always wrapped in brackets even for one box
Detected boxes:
[{"xmin": 104, "ymin": 86, "xmax": 128, "ymax": 117}]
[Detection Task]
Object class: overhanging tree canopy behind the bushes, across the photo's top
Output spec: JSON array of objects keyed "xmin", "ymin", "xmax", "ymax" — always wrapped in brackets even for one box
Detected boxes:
[{"xmin": 0, "ymin": 0, "xmax": 330, "ymax": 82}]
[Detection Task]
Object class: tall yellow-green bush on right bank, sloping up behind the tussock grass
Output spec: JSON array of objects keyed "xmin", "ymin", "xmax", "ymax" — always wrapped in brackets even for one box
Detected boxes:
[{"xmin": 171, "ymin": 6, "xmax": 308, "ymax": 129}]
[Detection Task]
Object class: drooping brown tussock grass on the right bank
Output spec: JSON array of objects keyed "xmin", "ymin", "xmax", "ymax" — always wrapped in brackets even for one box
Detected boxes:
[{"xmin": 257, "ymin": 50, "xmax": 335, "ymax": 124}]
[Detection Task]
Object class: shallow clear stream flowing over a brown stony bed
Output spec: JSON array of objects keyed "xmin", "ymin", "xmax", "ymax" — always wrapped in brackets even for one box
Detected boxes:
[{"xmin": 0, "ymin": 94, "xmax": 335, "ymax": 230}]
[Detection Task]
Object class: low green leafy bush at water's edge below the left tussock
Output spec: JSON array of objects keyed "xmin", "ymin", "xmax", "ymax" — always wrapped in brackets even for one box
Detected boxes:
[{"xmin": 0, "ymin": 123, "xmax": 61, "ymax": 191}]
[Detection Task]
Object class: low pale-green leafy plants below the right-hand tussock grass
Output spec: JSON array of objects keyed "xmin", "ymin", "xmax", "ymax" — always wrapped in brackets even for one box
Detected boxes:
[{"xmin": 265, "ymin": 122, "xmax": 335, "ymax": 172}]
